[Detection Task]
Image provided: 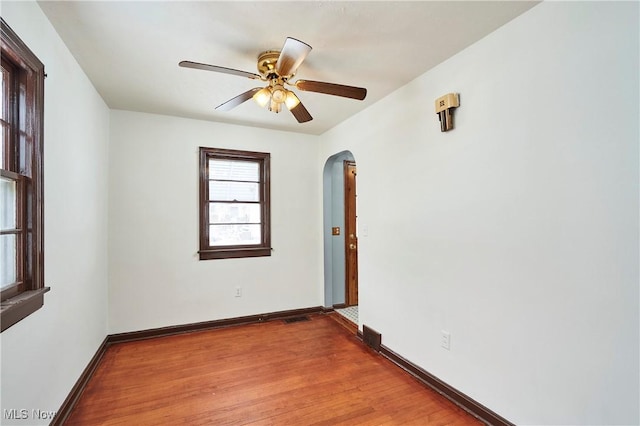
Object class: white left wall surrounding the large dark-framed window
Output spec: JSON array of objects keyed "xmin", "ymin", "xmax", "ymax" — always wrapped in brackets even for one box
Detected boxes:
[{"xmin": 0, "ymin": 1, "xmax": 109, "ymax": 425}]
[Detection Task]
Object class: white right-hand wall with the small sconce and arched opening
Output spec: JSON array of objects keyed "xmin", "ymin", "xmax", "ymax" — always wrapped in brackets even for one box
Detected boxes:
[{"xmin": 318, "ymin": 2, "xmax": 640, "ymax": 425}]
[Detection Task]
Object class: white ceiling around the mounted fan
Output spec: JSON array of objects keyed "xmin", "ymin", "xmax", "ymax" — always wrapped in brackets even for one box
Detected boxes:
[{"xmin": 39, "ymin": 1, "xmax": 537, "ymax": 135}]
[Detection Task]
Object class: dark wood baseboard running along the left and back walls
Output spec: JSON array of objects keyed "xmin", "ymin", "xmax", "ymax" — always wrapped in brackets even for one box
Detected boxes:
[{"xmin": 50, "ymin": 306, "xmax": 326, "ymax": 426}]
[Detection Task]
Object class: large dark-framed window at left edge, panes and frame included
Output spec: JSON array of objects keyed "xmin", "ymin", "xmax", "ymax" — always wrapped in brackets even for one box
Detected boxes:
[{"xmin": 0, "ymin": 19, "xmax": 49, "ymax": 331}]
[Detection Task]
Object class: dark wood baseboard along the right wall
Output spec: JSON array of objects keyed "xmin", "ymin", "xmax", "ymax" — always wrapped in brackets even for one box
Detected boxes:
[{"xmin": 380, "ymin": 345, "xmax": 515, "ymax": 426}]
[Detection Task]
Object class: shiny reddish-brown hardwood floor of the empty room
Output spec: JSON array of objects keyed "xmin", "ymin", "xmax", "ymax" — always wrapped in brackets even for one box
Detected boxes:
[{"xmin": 65, "ymin": 314, "xmax": 481, "ymax": 426}]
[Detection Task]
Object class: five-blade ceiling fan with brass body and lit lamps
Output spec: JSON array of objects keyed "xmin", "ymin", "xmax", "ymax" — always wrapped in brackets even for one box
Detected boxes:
[{"xmin": 178, "ymin": 37, "xmax": 367, "ymax": 123}]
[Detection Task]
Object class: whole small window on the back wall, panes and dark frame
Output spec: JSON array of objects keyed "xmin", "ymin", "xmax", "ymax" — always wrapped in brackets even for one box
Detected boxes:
[{"xmin": 200, "ymin": 148, "xmax": 271, "ymax": 260}]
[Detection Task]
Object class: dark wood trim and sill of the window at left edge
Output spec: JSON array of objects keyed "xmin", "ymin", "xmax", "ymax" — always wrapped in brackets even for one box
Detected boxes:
[{"xmin": 0, "ymin": 19, "xmax": 49, "ymax": 331}]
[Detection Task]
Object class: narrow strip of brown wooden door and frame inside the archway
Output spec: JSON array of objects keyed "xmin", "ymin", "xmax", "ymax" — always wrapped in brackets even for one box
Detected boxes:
[{"xmin": 344, "ymin": 160, "xmax": 358, "ymax": 306}]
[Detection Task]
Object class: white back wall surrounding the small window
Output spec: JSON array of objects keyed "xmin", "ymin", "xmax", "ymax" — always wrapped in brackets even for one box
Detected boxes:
[{"xmin": 109, "ymin": 111, "xmax": 323, "ymax": 333}]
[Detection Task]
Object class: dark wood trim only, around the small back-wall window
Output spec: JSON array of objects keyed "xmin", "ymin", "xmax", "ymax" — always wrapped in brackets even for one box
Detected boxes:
[{"xmin": 199, "ymin": 147, "xmax": 271, "ymax": 260}]
